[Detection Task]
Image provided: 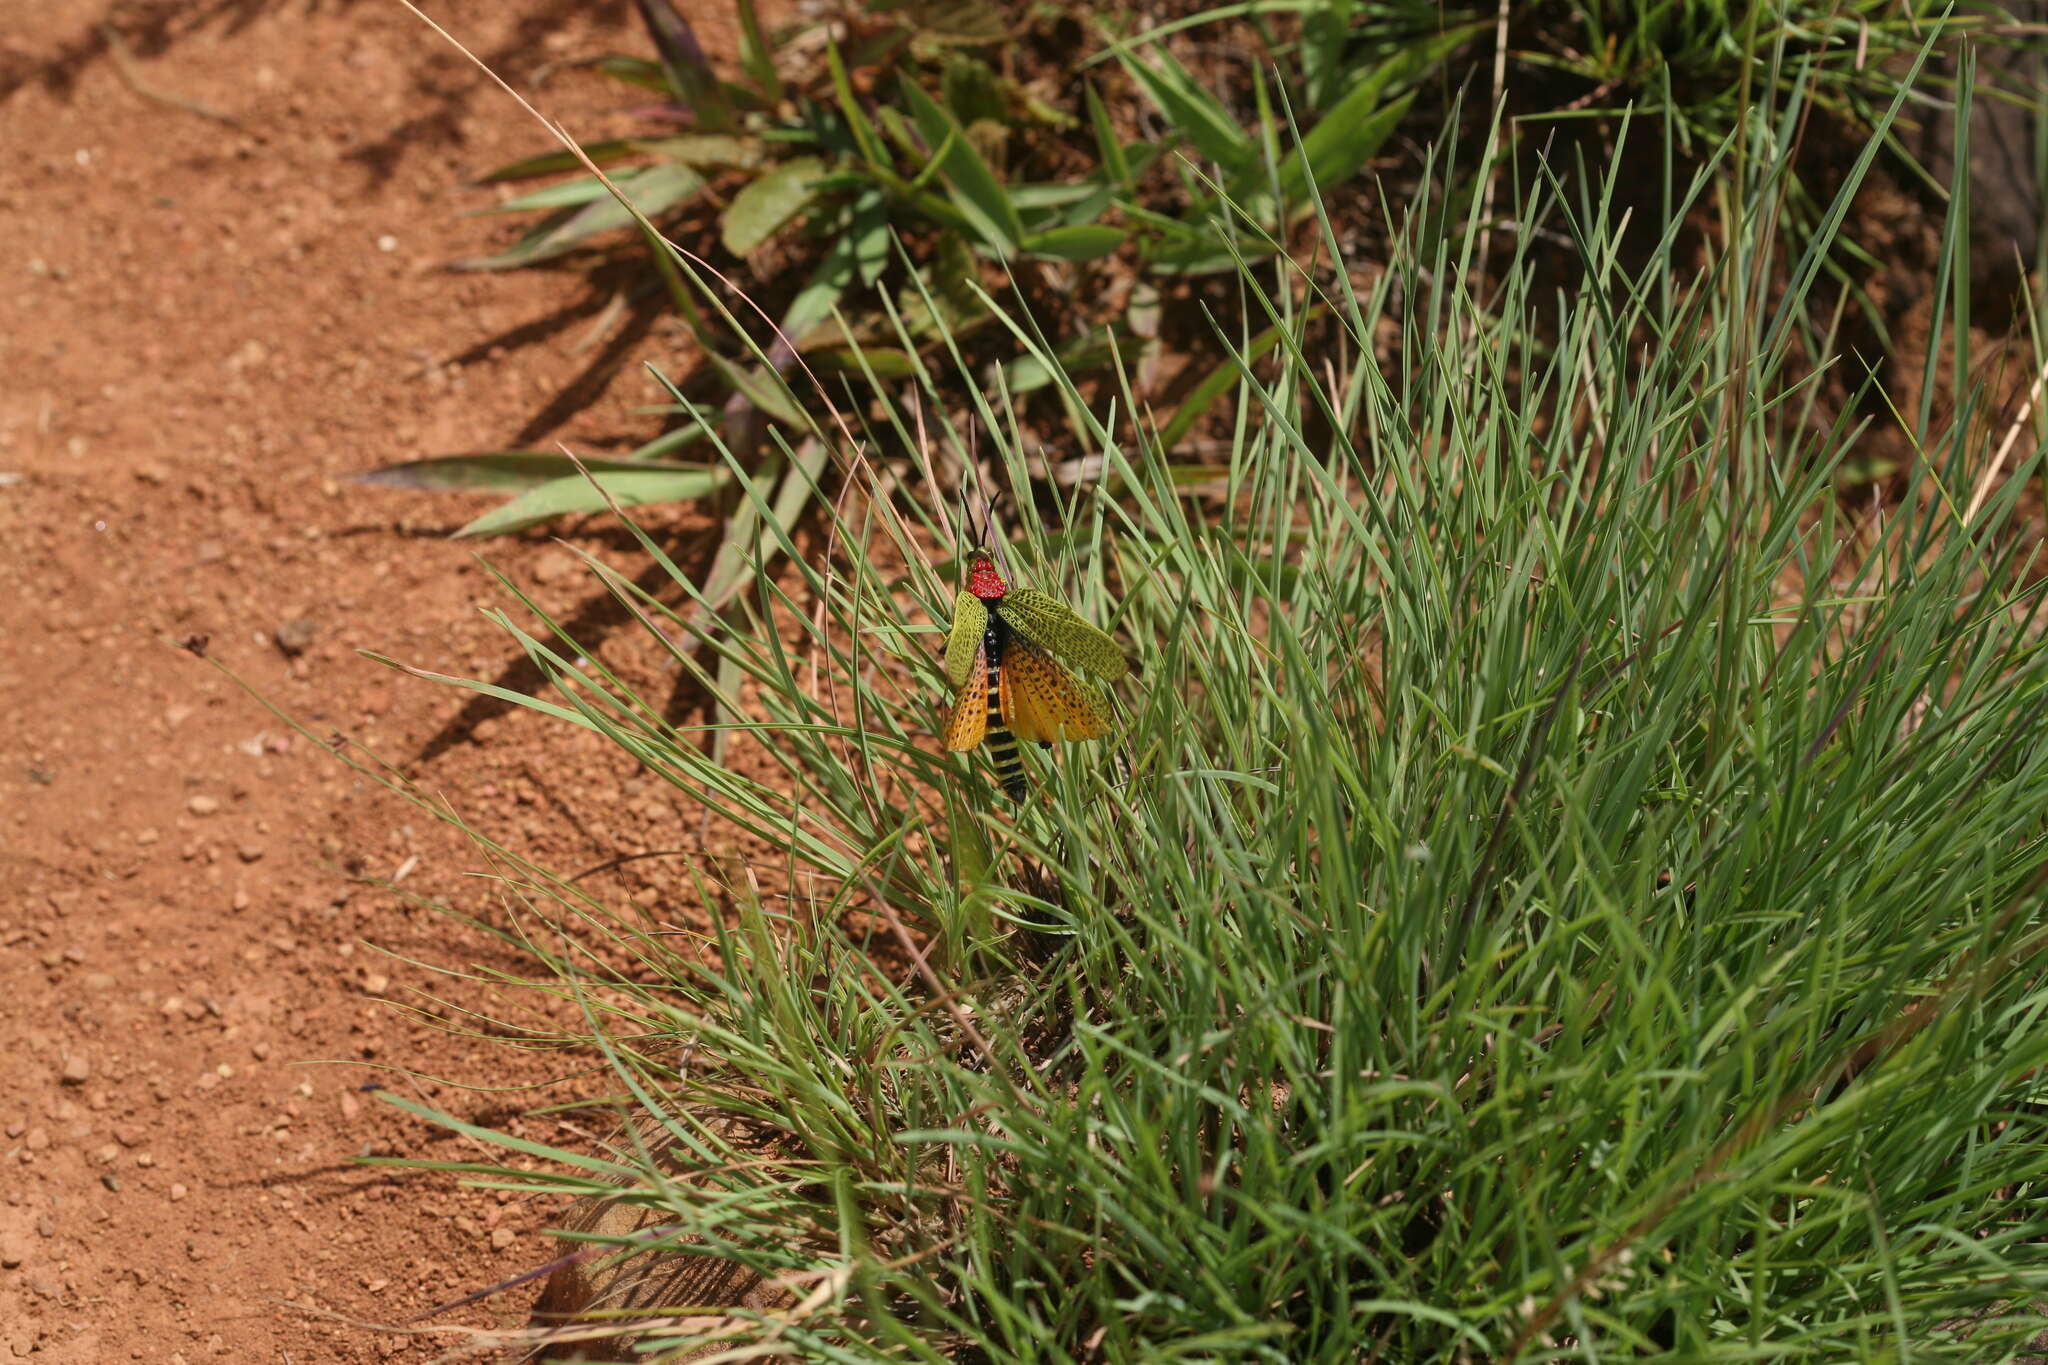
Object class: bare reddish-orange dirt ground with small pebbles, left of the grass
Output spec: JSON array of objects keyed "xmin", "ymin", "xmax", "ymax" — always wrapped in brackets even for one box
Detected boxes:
[{"xmin": 0, "ymin": 0, "xmax": 753, "ymax": 1365}]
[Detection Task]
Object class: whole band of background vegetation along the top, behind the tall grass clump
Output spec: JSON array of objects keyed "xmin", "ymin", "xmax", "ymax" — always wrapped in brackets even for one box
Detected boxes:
[{"xmin": 371, "ymin": 0, "xmax": 2048, "ymax": 536}]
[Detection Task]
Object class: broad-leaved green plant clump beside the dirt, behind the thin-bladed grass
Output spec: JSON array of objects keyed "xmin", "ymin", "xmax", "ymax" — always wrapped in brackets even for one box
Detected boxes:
[{"xmin": 371, "ymin": 0, "xmax": 1477, "ymax": 536}]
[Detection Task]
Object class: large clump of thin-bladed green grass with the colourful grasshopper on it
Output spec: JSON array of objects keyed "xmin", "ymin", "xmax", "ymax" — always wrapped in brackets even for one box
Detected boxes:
[{"xmin": 356, "ymin": 61, "xmax": 2048, "ymax": 1363}]
